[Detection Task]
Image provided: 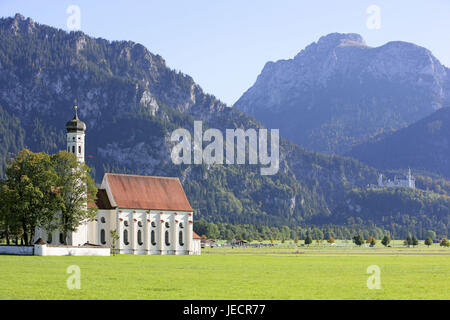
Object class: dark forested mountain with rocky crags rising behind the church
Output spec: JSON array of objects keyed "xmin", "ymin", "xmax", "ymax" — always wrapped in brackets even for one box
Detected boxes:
[{"xmin": 0, "ymin": 14, "xmax": 450, "ymax": 236}]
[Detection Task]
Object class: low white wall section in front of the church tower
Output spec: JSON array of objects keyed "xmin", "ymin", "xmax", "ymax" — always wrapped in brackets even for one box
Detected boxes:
[{"xmin": 34, "ymin": 245, "xmax": 111, "ymax": 257}]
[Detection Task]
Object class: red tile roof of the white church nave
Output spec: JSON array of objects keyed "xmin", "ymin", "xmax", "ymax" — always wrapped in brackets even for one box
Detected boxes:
[{"xmin": 105, "ymin": 173, "xmax": 193, "ymax": 211}]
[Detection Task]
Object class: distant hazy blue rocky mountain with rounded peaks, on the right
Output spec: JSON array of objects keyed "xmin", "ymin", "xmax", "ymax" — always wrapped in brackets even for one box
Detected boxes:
[{"xmin": 234, "ymin": 33, "xmax": 450, "ymax": 154}]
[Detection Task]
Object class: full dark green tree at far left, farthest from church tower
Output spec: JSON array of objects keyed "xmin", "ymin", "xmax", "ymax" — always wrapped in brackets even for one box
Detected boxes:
[{"xmin": 0, "ymin": 149, "xmax": 60, "ymax": 245}]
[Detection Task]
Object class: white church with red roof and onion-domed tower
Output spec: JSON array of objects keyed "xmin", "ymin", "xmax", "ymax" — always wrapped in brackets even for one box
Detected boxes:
[{"xmin": 36, "ymin": 107, "xmax": 201, "ymax": 255}]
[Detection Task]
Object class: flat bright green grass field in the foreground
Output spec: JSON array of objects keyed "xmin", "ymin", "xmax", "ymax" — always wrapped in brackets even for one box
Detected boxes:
[{"xmin": 0, "ymin": 248, "xmax": 450, "ymax": 300}]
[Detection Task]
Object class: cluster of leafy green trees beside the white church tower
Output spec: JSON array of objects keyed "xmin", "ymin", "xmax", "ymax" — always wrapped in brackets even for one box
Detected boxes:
[{"xmin": 0, "ymin": 149, "xmax": 97, "ymax": 245}]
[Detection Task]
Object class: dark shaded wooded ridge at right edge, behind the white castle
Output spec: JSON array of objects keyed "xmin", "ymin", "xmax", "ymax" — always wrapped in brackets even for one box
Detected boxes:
[{"xmin": 348, "ymin": 108, "xmax": 450, "ymax": 179}]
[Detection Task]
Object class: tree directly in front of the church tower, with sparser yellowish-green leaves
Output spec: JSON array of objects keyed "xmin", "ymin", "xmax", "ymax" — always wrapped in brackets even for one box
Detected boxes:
[{"xmin": 51, "ymin": 151, "xmax": 98, "ymax": 244}]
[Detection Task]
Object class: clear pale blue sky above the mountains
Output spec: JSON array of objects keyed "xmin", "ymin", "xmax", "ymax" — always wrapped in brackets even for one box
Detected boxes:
[{"xmin": 0, "ymin": 0, "xmax": 450, "ymax": 105}]
